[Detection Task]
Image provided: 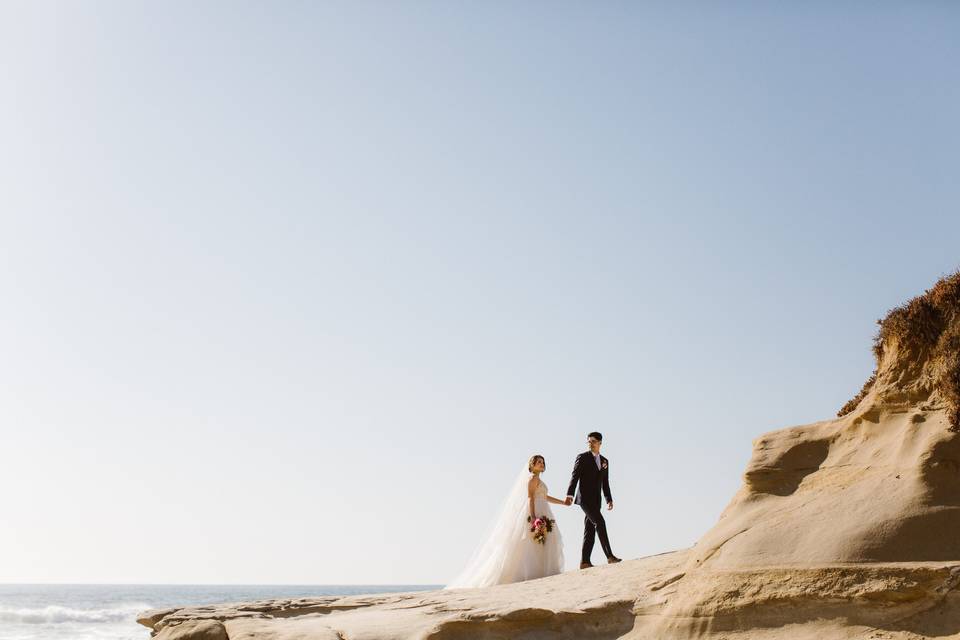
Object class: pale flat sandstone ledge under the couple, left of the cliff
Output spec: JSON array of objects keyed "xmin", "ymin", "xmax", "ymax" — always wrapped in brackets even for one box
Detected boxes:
[{"xmin": 141, "ymin": 552, "xmax": 685, "ymax": 640}]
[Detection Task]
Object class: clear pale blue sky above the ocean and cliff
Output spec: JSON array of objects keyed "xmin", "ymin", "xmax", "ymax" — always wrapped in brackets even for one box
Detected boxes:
[{"xmin": 0, "ymin": 1, "xmax": 960, "ymax": 583}]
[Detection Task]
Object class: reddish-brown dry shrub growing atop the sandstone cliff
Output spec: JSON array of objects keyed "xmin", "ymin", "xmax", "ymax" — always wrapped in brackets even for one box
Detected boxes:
[{"xmin": 837, "ymin": 271, "xmax": 960, "ymax": 430}]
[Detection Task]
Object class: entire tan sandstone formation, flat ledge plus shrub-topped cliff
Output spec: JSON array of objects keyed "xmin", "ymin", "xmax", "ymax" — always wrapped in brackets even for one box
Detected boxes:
[{"xmin": 141, "ymin": 273, "xmax": 960, "ymax": 640}]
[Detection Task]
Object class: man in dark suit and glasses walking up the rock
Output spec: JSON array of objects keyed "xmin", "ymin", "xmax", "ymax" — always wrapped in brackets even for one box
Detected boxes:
[{"xmin": 564, "ymin": 431, "xmax": 620, "ymax": 569}]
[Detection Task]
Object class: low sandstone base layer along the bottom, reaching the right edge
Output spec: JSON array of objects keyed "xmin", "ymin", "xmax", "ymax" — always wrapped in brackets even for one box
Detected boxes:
[{"xmin": 137, "ymin": 551, "xmax": 960, "ymax": 640}]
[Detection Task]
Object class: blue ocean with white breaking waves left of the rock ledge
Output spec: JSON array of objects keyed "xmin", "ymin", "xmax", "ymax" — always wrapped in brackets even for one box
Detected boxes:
[{"xmin": 0, "ymin": 584, "xmax": 441, "ymax": 640}]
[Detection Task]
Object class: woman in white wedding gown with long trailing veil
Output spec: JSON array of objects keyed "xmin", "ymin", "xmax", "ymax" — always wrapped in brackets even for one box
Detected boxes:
[{"xmin": 444, "ymin": 455, "xmax": 565, "ymax": 589}]
